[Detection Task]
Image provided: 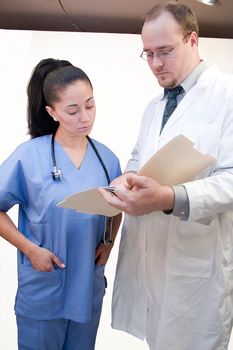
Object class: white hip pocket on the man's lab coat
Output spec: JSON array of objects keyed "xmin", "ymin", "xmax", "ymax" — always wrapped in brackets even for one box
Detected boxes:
[{"xmin": 167, "ymin": 218, "xmax": 219, "ymax": 278}]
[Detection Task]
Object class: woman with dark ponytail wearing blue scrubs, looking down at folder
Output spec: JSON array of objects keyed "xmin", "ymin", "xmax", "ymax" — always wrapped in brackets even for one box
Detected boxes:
[{"xmin": 0, "ymin": 59, "xmax": 121, "ymax": 350}]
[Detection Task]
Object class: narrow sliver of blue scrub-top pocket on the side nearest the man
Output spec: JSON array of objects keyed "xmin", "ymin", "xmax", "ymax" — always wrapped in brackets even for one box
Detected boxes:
[{"xmin": 92, "ymin": 265, "xmax": 107, "ymax": 313}]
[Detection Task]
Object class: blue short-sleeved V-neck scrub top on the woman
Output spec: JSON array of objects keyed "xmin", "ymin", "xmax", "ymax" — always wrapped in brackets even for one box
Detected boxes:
[{"xmin": 0, "ymin": 135, "xmax": 121, "ymax": 322}]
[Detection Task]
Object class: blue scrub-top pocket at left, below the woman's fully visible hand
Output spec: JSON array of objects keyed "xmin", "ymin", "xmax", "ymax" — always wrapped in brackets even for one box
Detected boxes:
[{"xmin": 18, "ymin": 265, "xmax": 65, "ymax": 304}]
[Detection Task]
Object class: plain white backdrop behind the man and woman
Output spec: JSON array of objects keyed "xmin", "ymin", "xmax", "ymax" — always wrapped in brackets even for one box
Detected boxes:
[{"xmin": 0, "ymin": 30, "xmax": 233, "ymax": 350}]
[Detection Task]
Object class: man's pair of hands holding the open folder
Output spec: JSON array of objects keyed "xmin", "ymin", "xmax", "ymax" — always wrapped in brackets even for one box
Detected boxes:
[{"xmin": 99, "ymin": 174, "xmax": 174, "ymax": 215}]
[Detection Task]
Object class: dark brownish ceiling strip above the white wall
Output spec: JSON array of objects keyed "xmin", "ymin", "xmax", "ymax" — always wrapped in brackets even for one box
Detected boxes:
[{"xmin": 0, "ymin": 0, "xmax": 233, "ymax": 38}]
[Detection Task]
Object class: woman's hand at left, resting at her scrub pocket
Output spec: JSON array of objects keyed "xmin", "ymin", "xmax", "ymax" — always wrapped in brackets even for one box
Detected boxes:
[{"xmin": 28, "ymin": 246, "xmax": 65, "ymax": 272}]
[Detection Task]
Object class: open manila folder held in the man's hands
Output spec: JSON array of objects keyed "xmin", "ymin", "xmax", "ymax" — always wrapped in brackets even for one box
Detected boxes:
[{"xmin": 58, "ymin": 135, "xmax": 215, "ymax": 216}]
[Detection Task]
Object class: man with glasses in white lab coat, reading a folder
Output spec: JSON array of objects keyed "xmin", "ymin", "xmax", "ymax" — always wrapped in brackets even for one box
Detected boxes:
[{"xmin": 102, "ymin": 3, "xmax": 233, "ymax": 350}]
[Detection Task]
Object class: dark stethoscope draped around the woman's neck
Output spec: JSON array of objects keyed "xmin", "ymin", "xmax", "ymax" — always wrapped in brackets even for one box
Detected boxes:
[{"xmin": 51, "ymin": 133, "xmax": 113, "ymax": 245}]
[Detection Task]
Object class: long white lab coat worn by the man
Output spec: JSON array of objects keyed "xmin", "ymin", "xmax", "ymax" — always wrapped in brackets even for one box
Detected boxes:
[{"xmin": 112, "ymin": 66, "xmax": 233, "ymax": 350}]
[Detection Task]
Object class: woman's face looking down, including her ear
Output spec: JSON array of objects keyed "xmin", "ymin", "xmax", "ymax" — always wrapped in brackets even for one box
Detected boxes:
[{"xmin": 46, "ymin": 80, "xmax": 96, "ymax": 137}]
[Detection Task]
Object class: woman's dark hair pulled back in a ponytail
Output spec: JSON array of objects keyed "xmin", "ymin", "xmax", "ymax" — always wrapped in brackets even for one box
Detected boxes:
[{"xmin": 27, "ymin": 58, "xmax": 92, "ymax": 138}]
